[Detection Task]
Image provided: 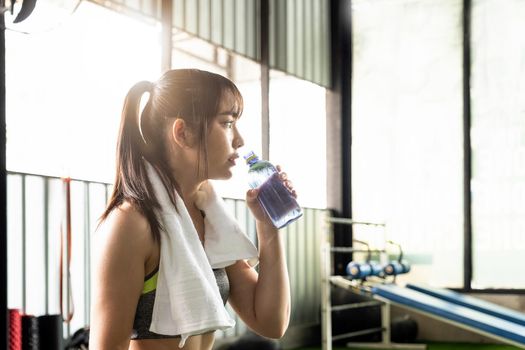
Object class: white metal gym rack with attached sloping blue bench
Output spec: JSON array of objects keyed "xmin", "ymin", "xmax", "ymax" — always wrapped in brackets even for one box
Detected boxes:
[{"xmin": 321, "ymin": 218, "xmax": 525, "ymax": 350}]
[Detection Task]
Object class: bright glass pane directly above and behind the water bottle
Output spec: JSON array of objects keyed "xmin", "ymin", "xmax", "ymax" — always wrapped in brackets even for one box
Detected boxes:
[{"xmin": 270, "ymin": 71, "xmax": 326, "ymax": 208}]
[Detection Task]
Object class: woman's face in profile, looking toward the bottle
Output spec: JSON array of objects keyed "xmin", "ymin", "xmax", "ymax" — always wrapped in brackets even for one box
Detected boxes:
[{"xmin": 206, "ymin": 92, "xmax": 244, "ymax": 180}]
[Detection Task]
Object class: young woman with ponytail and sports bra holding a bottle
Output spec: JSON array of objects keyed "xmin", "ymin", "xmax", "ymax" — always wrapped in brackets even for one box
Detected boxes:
[{"xmin": 90, "ymin": 69, "xmax": 296, "ymax": 350}]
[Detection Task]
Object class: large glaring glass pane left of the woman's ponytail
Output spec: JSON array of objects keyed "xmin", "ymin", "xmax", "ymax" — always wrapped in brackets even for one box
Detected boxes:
[{"xmin": 6, "ymin": 1, "xmax": 160, "ymax": 182}]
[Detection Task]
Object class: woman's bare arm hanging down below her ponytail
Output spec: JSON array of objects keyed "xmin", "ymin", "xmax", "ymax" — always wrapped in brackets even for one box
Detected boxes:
[{"xmin": 90, "ymin": 207, "xmax": 152, "ymax": 350}]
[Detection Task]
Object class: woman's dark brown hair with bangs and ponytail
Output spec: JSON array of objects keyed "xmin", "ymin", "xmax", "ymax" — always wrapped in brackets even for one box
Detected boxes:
[{"xmin": 100, "ymin": 69, "xmax": 243, "ymax": 240}]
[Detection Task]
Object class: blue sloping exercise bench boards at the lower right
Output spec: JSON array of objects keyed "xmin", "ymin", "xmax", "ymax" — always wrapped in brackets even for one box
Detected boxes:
[{"xmin": 372, "ymin": 284, "xmax": 525, "ymax": 349}]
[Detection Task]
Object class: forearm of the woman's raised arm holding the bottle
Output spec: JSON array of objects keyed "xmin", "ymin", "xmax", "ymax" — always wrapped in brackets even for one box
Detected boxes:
[{"xmin": 254, "ymin": 221, "xmax": 290, "ymax": 338}]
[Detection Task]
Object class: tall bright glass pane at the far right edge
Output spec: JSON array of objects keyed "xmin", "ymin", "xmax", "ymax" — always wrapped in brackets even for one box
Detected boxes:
[{"xmin": 471, "ymin": 0, "xmax": 525, "ymax": 288}]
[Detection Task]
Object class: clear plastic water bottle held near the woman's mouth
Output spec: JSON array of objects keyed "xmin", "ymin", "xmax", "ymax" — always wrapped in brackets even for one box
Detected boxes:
[{"xmin": 244, "ymin": 152, "xmax": 303, "ymax": 228}]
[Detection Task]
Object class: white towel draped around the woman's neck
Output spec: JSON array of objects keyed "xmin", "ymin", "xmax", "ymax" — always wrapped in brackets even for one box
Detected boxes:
[{"xmin": 145, "ymin": 162, "xmax": 258, "ymax": 348}]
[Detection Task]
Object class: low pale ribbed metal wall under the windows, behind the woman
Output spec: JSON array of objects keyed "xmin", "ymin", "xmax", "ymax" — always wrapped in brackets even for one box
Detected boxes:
[{"xmin": 7, "ymin": 172, "xmax": 327, "ymax": 344}]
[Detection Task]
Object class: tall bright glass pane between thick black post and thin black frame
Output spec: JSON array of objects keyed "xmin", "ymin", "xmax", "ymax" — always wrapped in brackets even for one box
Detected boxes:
[{"xmin": 352, "ymin": 0, "xmax": 463, "ymax": 287}]
